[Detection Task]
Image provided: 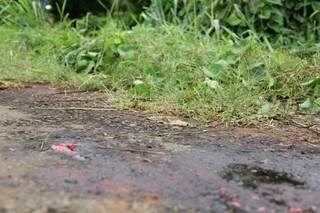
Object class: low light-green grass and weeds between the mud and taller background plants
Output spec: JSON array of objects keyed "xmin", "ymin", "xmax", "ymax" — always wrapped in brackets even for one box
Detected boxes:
[{"xmin": 0, "ymin": 20, "xmax": 320, "ymax": 124}]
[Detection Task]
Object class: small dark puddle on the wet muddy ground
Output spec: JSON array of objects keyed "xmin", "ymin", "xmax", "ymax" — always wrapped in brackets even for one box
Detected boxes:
[{"xmin": 221, "ymin": 164, "xmax": 305, "ymax": 189}]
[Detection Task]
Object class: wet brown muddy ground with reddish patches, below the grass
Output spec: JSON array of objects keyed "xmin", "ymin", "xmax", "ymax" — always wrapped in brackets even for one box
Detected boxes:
[{"xmin": 0, "ymin": 85, "xmax": 320, "ymax": 213}]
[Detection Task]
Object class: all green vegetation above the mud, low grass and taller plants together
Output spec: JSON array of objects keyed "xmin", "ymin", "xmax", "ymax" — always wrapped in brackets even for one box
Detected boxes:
[{"xmin": 0, "ymin": 0, "xmax": 320, "ymax": 124}]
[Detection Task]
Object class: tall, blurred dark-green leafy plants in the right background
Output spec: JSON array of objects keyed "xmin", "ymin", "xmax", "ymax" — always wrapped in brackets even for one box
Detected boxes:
[{"xmin": 143, "ymin": 0, "xmax": 320, "ymax": 44}]
